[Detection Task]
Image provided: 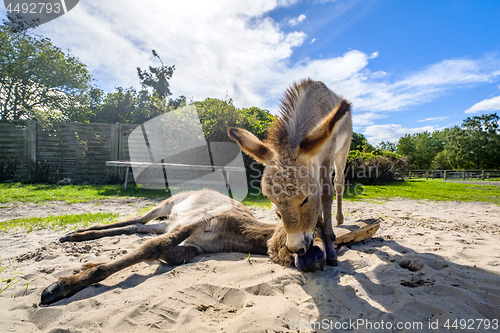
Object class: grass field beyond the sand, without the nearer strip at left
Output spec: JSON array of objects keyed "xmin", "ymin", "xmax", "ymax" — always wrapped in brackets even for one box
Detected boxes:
[{"xmin": 0, "ymin": 179, "xmax": 500, "ymax": 208}]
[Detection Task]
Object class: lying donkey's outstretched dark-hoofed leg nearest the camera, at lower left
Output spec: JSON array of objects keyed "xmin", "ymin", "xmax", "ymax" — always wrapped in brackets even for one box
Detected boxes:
[{"xmin": 41, "ymin": 224, "xmax": 198, "ymax": 304}]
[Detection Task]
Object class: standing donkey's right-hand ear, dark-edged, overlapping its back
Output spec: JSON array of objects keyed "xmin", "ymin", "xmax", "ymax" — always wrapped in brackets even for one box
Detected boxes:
[{"xmin": 298, "ymin": 99, "xmax": 351, "ymax": 155}]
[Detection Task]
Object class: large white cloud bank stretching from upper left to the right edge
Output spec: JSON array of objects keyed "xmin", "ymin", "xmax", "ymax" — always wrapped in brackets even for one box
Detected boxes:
[{"xmin": 30, "ymin": 0, "xmax": 500, "ymax": 113}]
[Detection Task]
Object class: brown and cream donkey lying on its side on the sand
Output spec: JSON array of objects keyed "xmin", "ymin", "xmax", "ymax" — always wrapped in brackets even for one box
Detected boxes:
[{"xmin": 41, "ymin": 190, "xmax": 378, "ymax": 304}]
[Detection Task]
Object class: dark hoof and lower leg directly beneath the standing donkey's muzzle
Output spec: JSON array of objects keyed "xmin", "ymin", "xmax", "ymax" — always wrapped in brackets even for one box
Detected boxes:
[{"xmin": 294, "ymin": 225, "xmax": 326, "ymax": 272}]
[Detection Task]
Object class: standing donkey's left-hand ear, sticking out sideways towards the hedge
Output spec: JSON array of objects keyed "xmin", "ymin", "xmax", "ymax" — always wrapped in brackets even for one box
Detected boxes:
[{"xmin": 227, "ymin": 127, "xmax": 273, "ymax": 165}]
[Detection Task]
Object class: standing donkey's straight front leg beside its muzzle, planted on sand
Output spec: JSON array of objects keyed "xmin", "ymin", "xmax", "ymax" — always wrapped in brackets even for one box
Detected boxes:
[{"xmin": 318, "ymin": 161, "xmax": 337, "ymax": 266}]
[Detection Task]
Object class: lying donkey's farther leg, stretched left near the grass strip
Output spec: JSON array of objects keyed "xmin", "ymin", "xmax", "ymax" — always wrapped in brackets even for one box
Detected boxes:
[{"xmin": 59, "ymin": 199, "xmax": 174, "ymax": 243}]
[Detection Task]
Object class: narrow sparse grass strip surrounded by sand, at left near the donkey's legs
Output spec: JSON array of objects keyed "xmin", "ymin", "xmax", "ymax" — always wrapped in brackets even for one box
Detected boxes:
[{"xmin": 0, "ymin": 213, "xmax": 119, "ymax": 232}]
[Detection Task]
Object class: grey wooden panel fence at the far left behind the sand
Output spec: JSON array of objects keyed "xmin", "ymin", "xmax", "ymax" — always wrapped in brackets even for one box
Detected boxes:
[{"xmin": 0, "ymin": 120, "xmax": 138, "ymax": 183}]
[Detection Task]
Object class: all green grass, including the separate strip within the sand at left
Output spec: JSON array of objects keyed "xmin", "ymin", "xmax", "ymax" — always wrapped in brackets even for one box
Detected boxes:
[{"xmin": 0, "ymin": 179, "xmax": 500, "ymax": 231}]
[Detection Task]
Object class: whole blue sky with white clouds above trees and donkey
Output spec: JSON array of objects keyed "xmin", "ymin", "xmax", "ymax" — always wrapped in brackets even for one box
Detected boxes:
[{"xmin": 1, "ymin": 0, "xmax": 500, "ymax": 144}]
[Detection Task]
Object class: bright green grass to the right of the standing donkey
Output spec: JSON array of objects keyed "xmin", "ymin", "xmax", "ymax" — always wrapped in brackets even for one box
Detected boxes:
[{"xmin": 345, "ymin": 179, "xmax": 500, "ymax": 205}]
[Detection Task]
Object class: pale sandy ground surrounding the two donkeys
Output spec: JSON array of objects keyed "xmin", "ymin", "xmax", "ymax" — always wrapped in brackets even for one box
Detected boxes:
[{"xmin": 0, "ymin": 199, "xmax": 500, "ymax": 333}]
